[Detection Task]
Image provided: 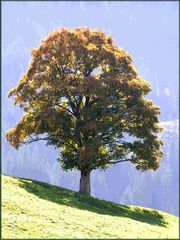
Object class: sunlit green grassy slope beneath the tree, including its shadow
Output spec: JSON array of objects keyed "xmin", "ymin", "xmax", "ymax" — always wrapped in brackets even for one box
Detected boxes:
[{"xmin": 2, "ymin": 175, "xmax": 179, "ymax": 239}]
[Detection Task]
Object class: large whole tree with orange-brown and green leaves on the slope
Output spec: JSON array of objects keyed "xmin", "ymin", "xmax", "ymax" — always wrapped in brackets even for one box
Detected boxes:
[{"xmin": 6, "ymin": 28, "xmax": 163, "ymax": 195}]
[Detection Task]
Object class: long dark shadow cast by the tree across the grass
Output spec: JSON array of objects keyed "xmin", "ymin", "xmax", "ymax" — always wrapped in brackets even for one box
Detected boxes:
[{"xmin": 19, "ymin": 179, "xmax": 167, "ymax": 227}]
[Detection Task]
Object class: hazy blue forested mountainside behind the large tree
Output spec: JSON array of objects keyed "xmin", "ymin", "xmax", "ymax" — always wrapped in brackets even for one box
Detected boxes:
[{"xmin": 2, "ymin": 2, "xmax": 179, "ymax": 215}]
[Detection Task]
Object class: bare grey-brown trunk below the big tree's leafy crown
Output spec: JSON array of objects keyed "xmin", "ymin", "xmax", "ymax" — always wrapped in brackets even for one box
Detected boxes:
[{"xmin": 79, "ymin": 170, "xmax": 91, "ymax": 195}]
